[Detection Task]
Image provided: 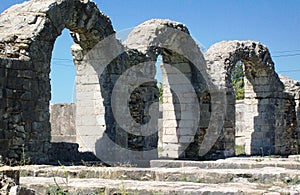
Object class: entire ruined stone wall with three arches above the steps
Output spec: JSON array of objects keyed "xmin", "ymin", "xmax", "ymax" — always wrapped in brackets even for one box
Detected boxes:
[{"xmin": 0, "ymin": 0, "xmax": 300, "ymax": 166}]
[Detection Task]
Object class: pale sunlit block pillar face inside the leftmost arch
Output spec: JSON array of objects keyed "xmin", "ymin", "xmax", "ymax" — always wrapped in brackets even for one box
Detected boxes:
[{"xmin": 72, "ymin": 45, "xmax": 106, "ymax": 152}]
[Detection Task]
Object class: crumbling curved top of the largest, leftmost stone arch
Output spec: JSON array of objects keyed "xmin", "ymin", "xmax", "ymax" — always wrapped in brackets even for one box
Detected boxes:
[{"xmin": 0, "ymin": 0, "xmax": 114, "ymax": 60}]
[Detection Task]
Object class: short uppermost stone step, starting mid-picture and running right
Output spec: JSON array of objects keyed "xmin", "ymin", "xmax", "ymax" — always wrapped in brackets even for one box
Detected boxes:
[{"xmin": 150, "ymin": 155, "xmax": 300, "ymax": 170}]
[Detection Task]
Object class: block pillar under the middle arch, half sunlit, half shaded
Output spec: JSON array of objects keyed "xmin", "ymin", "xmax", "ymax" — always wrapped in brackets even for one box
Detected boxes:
[{"xmin": 160, "ymin": 54, "xmax": 199, "ymax": 158}]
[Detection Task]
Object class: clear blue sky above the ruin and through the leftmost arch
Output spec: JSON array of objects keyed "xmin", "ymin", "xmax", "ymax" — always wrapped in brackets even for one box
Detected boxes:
[{"xmin": 0, "ymin": 0, "xmax": 300, "ymax": 103}]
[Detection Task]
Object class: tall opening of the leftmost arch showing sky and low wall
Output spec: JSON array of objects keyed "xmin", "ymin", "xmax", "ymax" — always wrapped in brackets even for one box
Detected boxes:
[{"xmin": 50, "ymin": 29, "xmax": 76, "ymax": 148}]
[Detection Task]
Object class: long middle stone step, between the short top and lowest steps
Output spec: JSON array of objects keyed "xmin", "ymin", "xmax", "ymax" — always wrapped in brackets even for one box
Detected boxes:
[{"xmin": 20, "ymin": 165, "xmax": 300, "ymax": 184}]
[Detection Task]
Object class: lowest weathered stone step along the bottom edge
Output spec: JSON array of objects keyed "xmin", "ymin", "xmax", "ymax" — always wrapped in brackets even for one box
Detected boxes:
[{"xmin": 20, "ymin": 177, "xmax": 300, "ymax": 195}]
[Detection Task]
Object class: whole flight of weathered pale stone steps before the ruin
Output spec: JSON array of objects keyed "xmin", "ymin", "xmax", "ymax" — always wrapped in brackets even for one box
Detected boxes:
[{"xmin": 1, "ymin": 156, "xmax": 300, "ymax": 195}]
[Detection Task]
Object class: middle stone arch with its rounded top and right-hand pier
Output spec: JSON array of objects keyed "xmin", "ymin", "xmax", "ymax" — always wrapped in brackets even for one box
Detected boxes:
[{"xmin": 124, "ymin": 19, "xmax": 234, "ymax": 159}]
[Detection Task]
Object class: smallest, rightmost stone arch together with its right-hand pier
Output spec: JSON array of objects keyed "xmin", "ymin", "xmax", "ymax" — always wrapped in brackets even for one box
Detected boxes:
[{"xmin": 205, "ymin": 41, "xmax": 296, "ymax": 155}]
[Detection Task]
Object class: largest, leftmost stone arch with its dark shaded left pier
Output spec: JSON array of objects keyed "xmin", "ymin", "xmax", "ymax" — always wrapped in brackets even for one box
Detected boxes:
[{"xmin": 0, "ymin": 0, "xmax": 114, "ymax": 162}]
